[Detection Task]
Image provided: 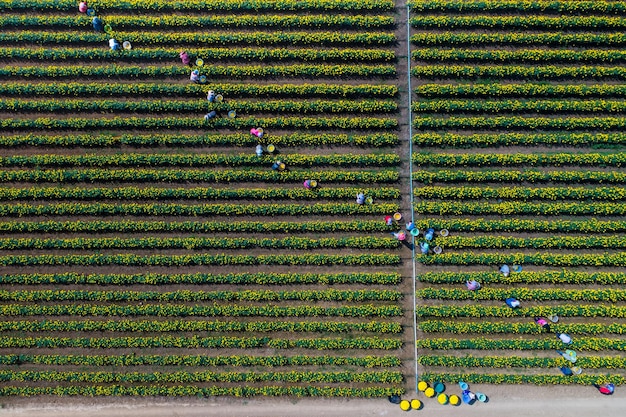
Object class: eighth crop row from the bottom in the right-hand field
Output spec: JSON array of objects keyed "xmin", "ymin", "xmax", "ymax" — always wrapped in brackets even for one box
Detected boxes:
[{"xmin": 414, "ymin": 252, "xmax": 626, "ymax": 267}]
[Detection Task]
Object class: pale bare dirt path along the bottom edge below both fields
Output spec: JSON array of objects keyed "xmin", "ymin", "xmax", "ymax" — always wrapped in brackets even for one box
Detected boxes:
[{"xmin": 0, "ymin": 385, "xmax": 626, "ymax": 417}]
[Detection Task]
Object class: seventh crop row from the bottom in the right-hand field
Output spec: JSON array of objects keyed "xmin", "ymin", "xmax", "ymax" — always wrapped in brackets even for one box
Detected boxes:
[{"xmin": 414, "ymin": 269, "xmax": 626, "ymax": 285}]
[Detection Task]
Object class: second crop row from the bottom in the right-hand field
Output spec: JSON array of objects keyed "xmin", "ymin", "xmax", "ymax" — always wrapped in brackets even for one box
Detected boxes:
[{"xmin": 418, "ymin": 352, "xmax": 626, "ymax": 369}]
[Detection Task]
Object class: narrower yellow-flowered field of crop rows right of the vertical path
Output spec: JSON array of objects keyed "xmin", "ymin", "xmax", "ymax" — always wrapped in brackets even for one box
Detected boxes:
[{"xmin": 410, "ymin": 0, "xmax": 626, "ymax": 385}]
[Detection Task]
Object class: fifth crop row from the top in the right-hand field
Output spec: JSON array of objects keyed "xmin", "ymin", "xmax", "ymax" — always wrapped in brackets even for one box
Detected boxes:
[{"xmin": 410, "ymin": 65, "xmax": 626, "ymax": 81}]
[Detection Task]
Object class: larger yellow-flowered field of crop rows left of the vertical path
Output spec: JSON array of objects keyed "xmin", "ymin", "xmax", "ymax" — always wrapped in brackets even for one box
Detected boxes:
[{"xmin": 0, "ymin": 0, "xmax": 408, "ymax": 397}]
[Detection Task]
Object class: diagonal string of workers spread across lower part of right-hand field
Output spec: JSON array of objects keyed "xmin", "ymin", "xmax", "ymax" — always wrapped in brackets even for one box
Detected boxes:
[{"xmin": 465, "ymin": 265, "xmax": 615, "ymax": 395}]
